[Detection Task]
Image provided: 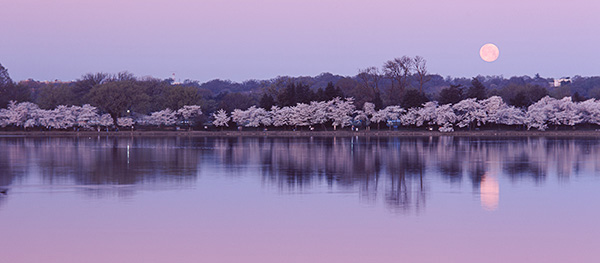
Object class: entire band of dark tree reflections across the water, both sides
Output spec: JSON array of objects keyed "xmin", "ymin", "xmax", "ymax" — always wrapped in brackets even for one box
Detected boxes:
[{"xmin": 0, "ymin": 137, "xmax": 600, "ymax": 213}]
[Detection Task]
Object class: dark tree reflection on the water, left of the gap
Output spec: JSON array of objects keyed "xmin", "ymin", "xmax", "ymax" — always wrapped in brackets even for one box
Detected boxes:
[{"xmin": 0, "ymin": 137, "xmax": 199, "ymax": 200}]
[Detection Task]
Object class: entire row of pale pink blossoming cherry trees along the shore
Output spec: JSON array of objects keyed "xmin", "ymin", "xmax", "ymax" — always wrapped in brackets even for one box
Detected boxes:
[{"xmin": 0, "ymin": 96, "xmax": 600, "ymax": 132}]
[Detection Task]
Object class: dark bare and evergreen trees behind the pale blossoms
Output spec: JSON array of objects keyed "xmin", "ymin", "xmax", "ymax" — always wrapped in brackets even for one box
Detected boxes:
[{"xmin": 0, "ymin": 56, "xmax": 600, "ymax": 132}]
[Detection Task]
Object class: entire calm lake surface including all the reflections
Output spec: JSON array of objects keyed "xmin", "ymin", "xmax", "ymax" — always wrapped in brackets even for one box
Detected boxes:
[{"xmin": 0, "ymin": 137, "xmax": 600, "ymax": 263}]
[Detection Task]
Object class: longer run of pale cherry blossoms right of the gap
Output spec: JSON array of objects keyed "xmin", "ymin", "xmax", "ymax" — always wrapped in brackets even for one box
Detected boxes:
[{"xmin": 213, "ymin": 96, "xmax": 600, "ymax": 132}]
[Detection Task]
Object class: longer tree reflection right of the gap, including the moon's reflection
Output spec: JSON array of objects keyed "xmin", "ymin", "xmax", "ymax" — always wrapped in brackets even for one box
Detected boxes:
[{"xmin": 214, "ymin": 137, "xmax": 598, "ymax": 212}]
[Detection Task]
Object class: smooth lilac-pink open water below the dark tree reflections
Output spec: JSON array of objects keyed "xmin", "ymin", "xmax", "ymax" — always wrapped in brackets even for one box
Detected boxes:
[{"xmin": 0, "ymin": 137, "xmax": 600, "ymax": 262}]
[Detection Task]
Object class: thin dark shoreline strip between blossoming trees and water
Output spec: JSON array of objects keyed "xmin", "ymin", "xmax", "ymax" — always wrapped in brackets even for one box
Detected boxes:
[{"xmin": 0, "ymin": 130, "xmax": 600, "ymax": 137}]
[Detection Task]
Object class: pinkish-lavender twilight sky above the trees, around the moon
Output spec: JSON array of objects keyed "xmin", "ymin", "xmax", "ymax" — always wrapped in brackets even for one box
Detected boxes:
[{"xmin": 0, "ymin": 0, "xmax": 600, "ymax": 82}]
